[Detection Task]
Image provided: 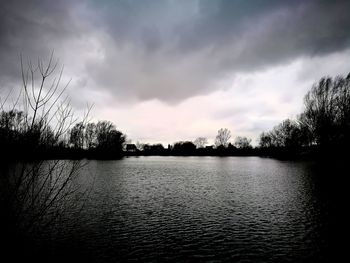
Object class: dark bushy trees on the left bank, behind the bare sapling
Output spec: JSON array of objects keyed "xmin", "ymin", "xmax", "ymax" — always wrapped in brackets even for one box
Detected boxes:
[{"xmin": 0, "ymin": 110, "xmax": 126, "ymax": 159}]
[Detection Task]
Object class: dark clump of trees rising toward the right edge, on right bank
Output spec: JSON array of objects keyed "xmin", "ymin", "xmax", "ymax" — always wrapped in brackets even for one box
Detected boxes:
[{"xmin": 259, "ymin": 73, "xmax": 350, "ymax": 159}]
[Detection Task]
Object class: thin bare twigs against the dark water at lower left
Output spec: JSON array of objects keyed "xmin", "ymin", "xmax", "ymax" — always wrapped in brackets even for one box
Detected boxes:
[{"xmin": 1, "ymin": 160, "xmax": 84, "ymax": 234}]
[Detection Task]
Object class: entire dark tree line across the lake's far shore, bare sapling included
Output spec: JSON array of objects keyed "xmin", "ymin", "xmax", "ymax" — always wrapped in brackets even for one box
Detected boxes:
[{"xmin": 0, "ymin": 52, "xmax": 350, "ymax": 159}]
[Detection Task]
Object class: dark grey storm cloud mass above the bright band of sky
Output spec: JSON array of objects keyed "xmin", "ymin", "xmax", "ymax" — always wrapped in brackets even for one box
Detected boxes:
[{"xmin": 0, "ymin": 0, "xmax": 350, "ymax": 102}]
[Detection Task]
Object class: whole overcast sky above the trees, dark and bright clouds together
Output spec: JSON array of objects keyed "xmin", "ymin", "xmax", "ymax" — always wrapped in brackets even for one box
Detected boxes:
[{"xmin": 0, "ymin": 0, "xmax": 350, "ymax": 145}]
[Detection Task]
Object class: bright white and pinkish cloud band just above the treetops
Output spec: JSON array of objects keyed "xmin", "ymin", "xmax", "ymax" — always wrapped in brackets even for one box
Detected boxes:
[{"xmin": 89, "ymin": 50, "xmax": 350, "ymax": 145}]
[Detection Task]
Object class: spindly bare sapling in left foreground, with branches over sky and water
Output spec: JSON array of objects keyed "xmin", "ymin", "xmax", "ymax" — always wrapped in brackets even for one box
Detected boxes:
[{"xmin": 0, "ymin": 53, "xmax": 91, "ymax": 238}]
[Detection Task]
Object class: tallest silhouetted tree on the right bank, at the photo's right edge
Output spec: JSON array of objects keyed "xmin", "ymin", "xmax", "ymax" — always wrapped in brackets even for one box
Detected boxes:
[{"xmin": 300, "ymin": 74, "xmax": 350, "ymax": 146}]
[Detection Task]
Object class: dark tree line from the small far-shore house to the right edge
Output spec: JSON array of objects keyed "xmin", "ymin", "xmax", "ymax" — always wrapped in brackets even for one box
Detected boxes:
[{"xmin": 129, "ymin": 73, "xmax": 350, "ymax": 158}]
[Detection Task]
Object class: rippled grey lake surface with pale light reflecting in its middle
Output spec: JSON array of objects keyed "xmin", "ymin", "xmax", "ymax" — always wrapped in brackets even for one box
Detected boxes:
[{"xmin": 39, "ymin": 157, "xmax": 344, "ymax": 262}]
